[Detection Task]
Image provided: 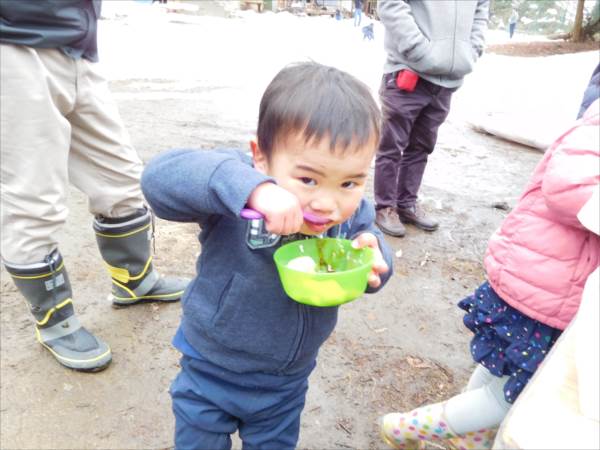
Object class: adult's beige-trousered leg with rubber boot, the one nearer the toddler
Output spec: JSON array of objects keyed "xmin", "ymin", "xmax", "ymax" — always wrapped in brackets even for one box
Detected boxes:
[{"xmin": 68, "ymin": 60, "xmax": 189, "ymax": 306}]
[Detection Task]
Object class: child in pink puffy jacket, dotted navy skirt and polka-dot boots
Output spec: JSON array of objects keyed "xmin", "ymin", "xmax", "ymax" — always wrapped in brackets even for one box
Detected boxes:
[{"xmin": 380, "ymin": 101, "xmax": 600, "ymax": 449}]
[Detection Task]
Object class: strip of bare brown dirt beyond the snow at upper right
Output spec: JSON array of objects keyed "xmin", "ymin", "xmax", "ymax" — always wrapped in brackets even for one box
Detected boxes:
[{"xmin": 486, "ymin": 41, "xmax": 600, "ymax": 57}]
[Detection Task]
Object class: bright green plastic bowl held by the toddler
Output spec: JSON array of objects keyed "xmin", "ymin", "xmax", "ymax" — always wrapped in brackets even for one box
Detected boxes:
[{"xmin": 273, "ymin": 238, "xmax": 373, "ymax": 306}]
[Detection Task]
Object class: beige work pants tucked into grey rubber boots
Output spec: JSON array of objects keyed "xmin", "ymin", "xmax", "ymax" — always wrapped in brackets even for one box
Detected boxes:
[{"xmin": 0, "ymin": 44, "xmax": 143, "ymax": 264}]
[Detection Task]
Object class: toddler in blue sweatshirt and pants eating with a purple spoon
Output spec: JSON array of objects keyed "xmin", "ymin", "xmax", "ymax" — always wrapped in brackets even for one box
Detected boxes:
[{"xmin": 142, "ymin": 63, "xmax": 392, "ymax": 450}]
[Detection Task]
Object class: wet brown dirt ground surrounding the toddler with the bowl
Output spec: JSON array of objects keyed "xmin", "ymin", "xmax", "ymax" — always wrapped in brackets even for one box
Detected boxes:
[{"xmin": 0, "ymin": 72, "xmax": 541, "ymax": 449}]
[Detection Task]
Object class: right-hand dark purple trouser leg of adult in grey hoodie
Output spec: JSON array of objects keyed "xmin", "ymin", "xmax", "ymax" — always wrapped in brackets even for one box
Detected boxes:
[{"xmin": 396, "ymin": 79, "xmax": 454, "ymax": 208}]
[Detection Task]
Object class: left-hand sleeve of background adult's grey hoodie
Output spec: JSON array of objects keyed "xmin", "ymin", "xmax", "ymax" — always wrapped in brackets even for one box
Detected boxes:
[{"xmin": 377, "ymin": 0, "xmax": 429, "ymax": 62}]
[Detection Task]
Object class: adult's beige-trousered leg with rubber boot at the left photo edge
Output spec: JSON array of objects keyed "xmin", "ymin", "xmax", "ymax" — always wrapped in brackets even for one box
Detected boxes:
[{"xmin": 0, "ymin": 45, "xmax": 111, "ymax": 371}]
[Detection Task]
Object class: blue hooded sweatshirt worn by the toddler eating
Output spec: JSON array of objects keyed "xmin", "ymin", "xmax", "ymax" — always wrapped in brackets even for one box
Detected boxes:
[{"xmin": 142, "ymin": 150, "xmax": 392, "ymax": 375}]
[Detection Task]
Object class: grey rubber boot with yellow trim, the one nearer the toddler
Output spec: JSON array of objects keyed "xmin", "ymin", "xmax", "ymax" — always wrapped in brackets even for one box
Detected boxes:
[{"xmin": 94, "ymin": 209, "xmax": 189, "ymax": 306}]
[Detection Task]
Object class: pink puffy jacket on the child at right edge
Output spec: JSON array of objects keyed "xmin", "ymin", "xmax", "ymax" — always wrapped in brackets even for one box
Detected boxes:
[{"xmin": 484, "ymin": 107, "xmax": 600, "ymax": 329}]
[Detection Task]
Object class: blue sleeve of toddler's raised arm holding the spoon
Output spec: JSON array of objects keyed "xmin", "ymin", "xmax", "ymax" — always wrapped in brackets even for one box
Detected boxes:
[{"xmin": 141, "ymin": 149, "xmax": 271, "ymax": 225}]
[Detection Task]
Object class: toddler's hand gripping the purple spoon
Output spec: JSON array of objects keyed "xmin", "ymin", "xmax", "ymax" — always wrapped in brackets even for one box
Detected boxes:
[{"xmin": 248, "ymin": 182, "xmax": 304, "ymax": 235}]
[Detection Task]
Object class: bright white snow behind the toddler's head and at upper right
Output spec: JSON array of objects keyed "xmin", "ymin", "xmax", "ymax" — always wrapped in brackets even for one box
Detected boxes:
[{"xmin": 99, "ymin": 6, "xmax": 597, "ymax": 149}]
